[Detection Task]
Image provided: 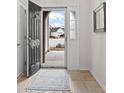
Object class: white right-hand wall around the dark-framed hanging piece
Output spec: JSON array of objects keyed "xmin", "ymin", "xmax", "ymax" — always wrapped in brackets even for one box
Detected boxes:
[{"xmin": 90, "ymin": 0, "xmax": 106, "ymax": 90}]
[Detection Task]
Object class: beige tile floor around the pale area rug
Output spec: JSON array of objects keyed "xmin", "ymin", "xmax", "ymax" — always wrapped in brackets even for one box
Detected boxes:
[{"xmin": 17, "ymin": 70, "xmax": 105, "ymax": 93}]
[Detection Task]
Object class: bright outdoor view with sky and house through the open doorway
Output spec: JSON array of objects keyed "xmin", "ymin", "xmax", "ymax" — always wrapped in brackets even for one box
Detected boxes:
[{"xmin": 42, "ymin": 8, "xmax": 66, "ymax": 68}]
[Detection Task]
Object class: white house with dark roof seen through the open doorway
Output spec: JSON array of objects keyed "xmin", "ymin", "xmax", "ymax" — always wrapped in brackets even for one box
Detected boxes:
[{"xmin": 50, "ymin": 27, "xmax": 64, "ymax": 38}]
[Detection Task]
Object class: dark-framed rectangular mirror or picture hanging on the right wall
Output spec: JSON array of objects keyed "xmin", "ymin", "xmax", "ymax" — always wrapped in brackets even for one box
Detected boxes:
[{"xmin": 93, "ymin": 2, "xmax": 106, "ymax": 32}]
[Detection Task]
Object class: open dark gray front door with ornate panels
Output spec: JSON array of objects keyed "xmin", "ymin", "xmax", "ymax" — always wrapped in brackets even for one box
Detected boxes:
[{"xmin": 28, "ymin": 2, "xmax": 41, "ymax": 75}]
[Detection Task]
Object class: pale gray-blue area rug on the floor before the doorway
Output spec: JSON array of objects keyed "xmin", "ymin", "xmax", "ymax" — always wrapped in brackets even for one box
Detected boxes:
[{"xmin": 26, "ymin": 69, "xmax": 70, "ymax": 93}]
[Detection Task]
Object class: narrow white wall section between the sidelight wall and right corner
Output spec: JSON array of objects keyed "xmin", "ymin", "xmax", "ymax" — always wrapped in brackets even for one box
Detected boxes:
[{"xmin": 79, "ymin": 0, "xmax": 91, "ymax": 70}]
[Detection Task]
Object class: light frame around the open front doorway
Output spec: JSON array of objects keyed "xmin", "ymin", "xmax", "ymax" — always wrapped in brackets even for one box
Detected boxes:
[{"xmin": 41, "ymin": 7, "xmax": 68, "ymax": 68}]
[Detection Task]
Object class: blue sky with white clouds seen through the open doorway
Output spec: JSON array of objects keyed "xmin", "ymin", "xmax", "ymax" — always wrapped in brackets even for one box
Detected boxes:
[{"xmin": 49, "ymin": 11, "xmax": 65, "ymax": 27}]
